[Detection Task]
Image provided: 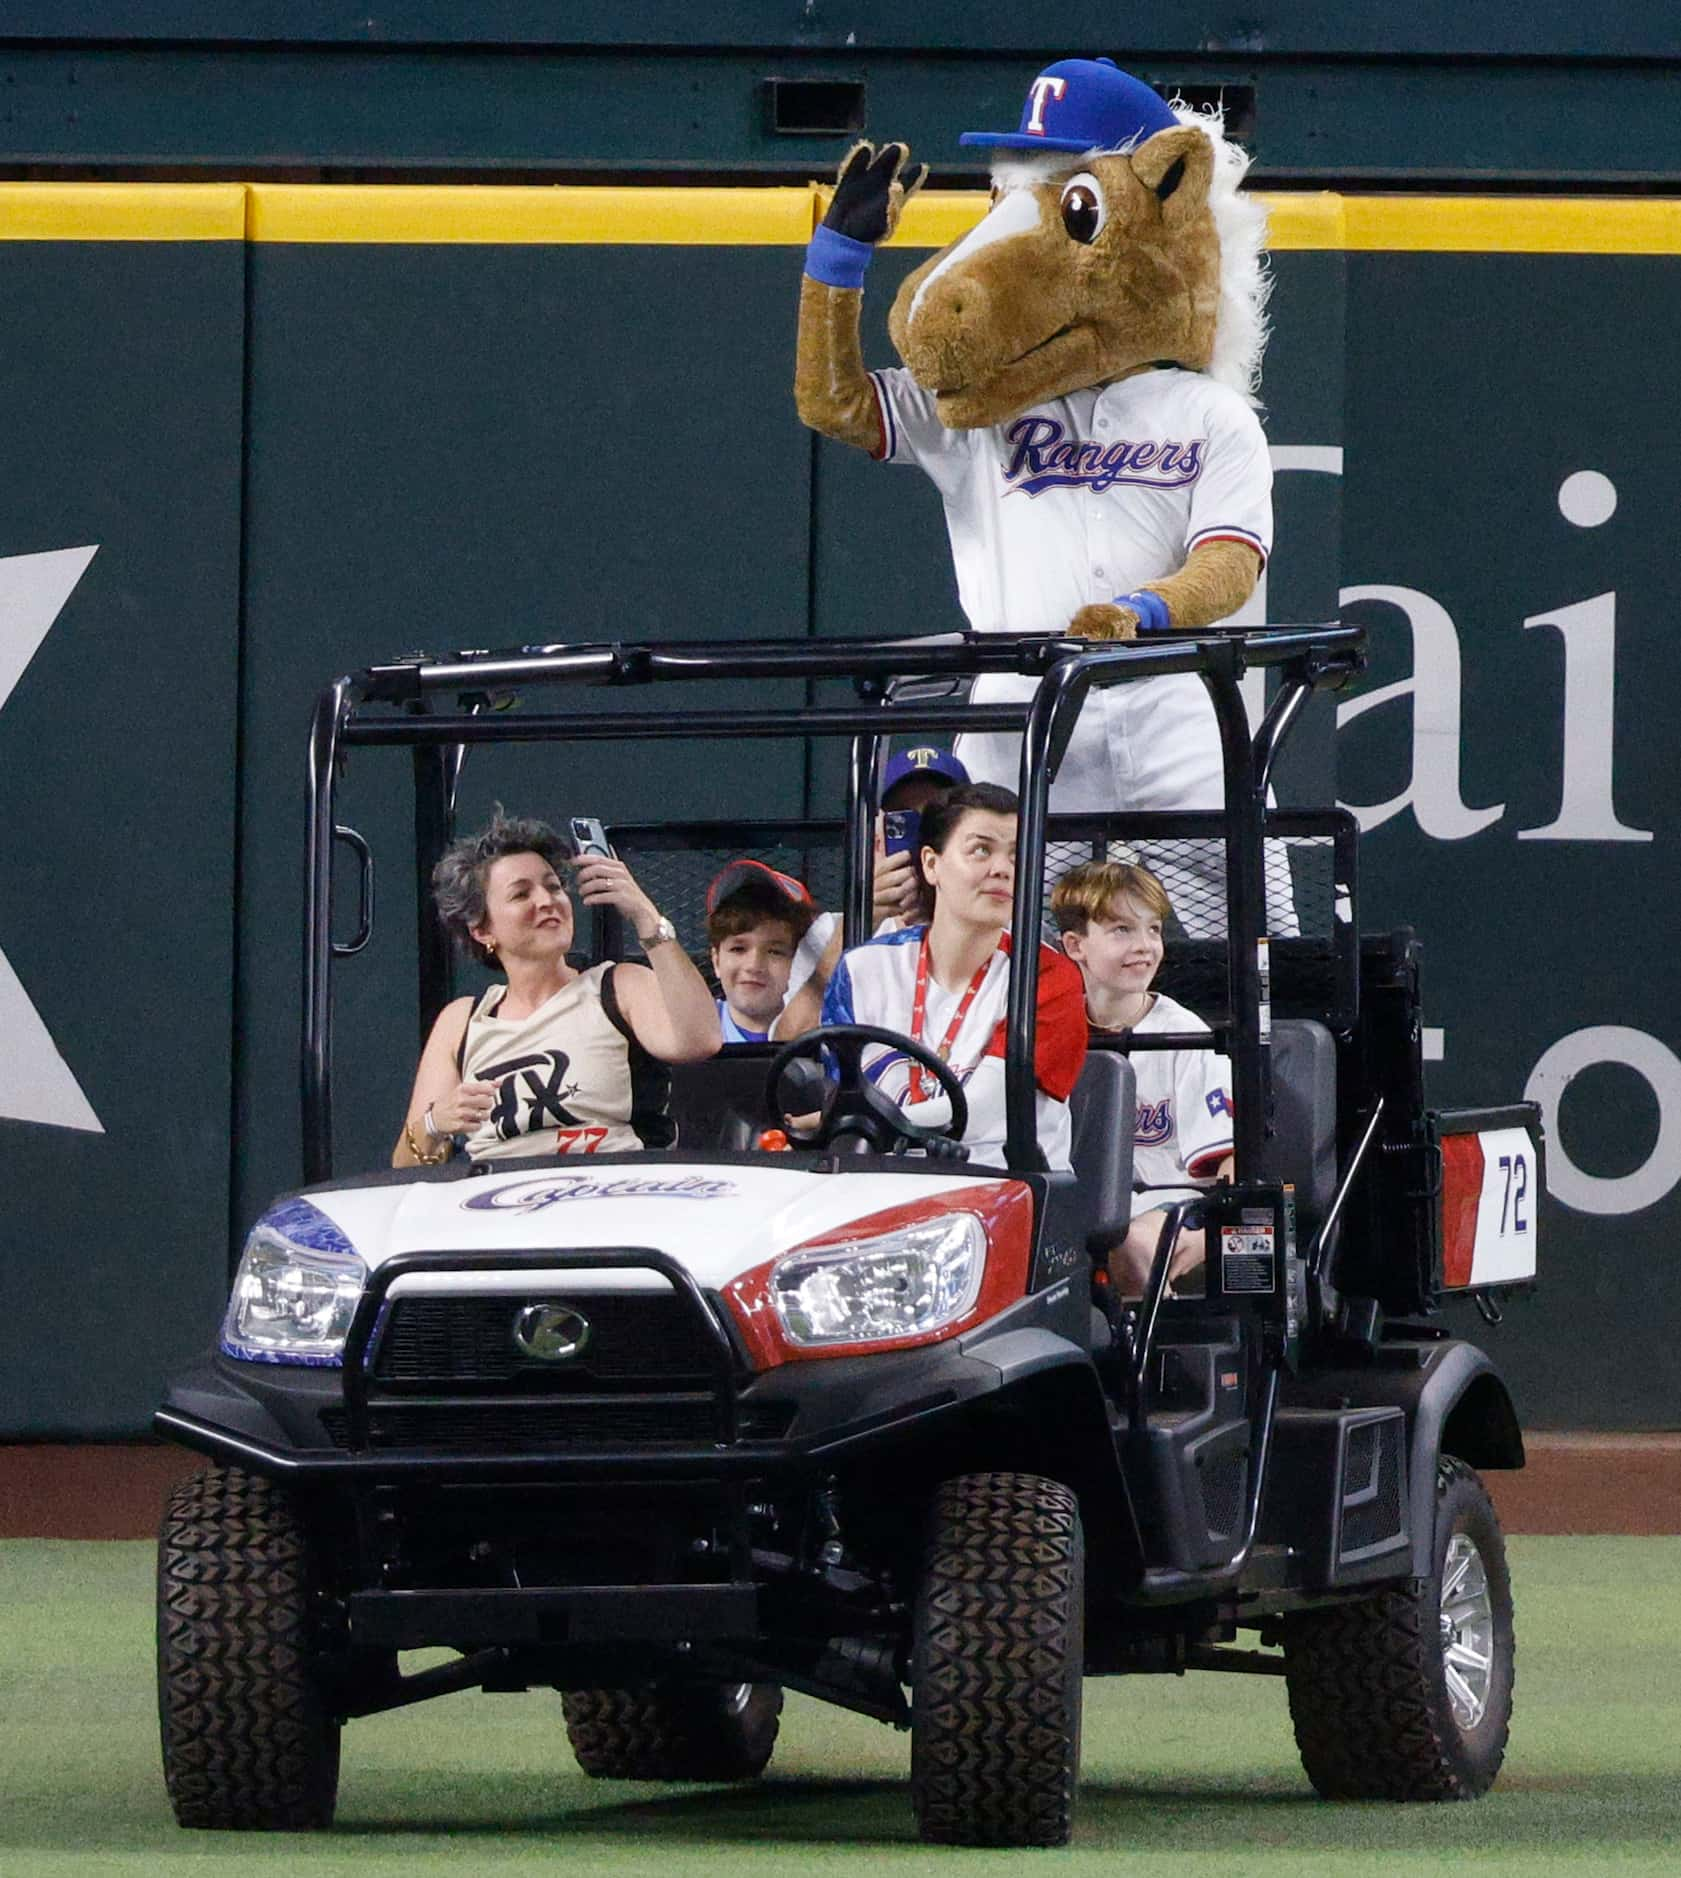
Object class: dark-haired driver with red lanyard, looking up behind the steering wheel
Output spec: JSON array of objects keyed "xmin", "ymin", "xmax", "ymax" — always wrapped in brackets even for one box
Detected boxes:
[{"xmin": 811, "ymin": 783, "xmax": 1086, "ymax": 1168}]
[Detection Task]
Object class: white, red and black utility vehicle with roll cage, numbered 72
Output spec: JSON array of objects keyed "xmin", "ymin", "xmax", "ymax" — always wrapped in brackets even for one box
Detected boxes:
[{"xmin": 156, "ymin": 625, "xmax": 1544, "ymax": 1846}]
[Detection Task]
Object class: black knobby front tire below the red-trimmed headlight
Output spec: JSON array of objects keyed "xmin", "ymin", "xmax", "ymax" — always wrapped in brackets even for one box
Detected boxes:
[{"xmin": 911, "ymin": 1474, "xmax": 1086, "ymax": 1846}]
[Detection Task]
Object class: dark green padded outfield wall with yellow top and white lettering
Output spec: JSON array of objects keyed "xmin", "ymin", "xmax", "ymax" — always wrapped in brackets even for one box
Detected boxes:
[{"xmin": 0, "ymin": 184, "xmax": 1681, "ymax": 1437}]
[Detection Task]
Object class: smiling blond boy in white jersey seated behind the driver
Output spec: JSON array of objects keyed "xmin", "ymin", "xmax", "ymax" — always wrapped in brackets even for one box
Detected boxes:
[{"xmin": 1050, "ymin": 860, "xmax": 1232, "ymax": 1298}]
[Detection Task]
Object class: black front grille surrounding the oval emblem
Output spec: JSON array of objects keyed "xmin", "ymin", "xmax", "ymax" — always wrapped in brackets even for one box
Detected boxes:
[{"xmin": 374, "ymin": 1292, "xmax": 717, "ymax": 1395}]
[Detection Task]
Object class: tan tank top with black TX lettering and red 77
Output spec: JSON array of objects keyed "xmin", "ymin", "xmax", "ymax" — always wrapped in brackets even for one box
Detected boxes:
[{"xmin": 456, "ymin": 963, "xmax": 676, "ymax": 1161}]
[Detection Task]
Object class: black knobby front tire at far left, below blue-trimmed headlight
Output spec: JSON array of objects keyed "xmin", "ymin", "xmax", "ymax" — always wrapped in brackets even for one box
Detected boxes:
[{"xmin": 158, "ymin": 1467, "xmax": 338, "ymax": 1831}]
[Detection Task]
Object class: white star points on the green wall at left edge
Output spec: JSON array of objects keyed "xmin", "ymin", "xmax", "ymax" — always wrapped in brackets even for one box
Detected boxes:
[{"xmin": 0, "ymin": 546, "xmax": 105, "ymax": 1134}]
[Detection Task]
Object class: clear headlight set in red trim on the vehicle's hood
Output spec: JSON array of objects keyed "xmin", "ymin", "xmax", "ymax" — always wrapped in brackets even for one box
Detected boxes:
[{"xmin": 770, "ymin": 1213, "xmax": 986, "ymax": 1347}]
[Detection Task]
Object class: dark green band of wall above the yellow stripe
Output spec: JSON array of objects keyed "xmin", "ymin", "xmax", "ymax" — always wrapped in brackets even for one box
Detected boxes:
[{"xmin": 0, "ymin": 23, "xmax": 1681, "ymax": 190}]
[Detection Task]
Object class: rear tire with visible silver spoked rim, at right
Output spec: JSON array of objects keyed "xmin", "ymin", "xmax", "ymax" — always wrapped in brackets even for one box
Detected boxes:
[{"xmin": 1285, "ymin": 1455, "xmax": 1512, "ymax": 1799}]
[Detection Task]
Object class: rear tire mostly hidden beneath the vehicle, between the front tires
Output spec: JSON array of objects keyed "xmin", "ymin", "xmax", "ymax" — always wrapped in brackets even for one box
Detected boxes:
[{"xmin": 562, "ymin": 1683, "xmax": 781, "ymax": 1780}]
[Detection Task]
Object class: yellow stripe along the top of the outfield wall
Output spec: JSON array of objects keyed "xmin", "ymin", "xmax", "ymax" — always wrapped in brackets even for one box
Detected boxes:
[{"xmin": 0, "ymin": 182, "xmax": 1681, "ymax": 255}]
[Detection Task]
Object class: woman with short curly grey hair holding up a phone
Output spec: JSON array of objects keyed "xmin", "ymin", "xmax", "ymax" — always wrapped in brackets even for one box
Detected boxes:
[{"xmin": 391, "ymin": 811, "xmax": 721, "ymax": 1166}]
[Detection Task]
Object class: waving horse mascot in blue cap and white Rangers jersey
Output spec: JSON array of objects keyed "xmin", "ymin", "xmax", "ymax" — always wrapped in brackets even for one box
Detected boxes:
[{"xmin": 794, "ymin": 58, "xmax": 1272, "ymax": 886}]
